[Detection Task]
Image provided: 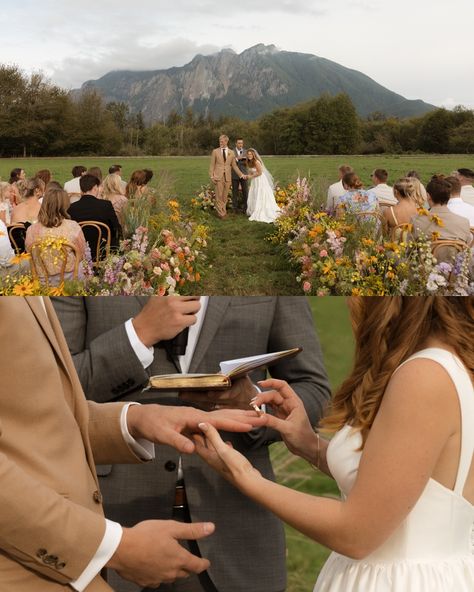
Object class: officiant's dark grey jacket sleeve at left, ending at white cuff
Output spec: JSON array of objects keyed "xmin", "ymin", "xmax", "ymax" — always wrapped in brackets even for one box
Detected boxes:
[{"xmin": 51, "ymin": 296, "xmax": 148, "ymax": 403}]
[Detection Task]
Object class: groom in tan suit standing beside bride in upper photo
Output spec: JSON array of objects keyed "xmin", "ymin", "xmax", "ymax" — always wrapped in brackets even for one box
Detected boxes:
[{"xmin": 209, "ymin": 135, "xmax": 247, "ymax": 218}]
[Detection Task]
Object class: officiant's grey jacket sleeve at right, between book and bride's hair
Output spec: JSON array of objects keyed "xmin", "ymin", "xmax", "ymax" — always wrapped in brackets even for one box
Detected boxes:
[{"xmin": 243, "ymin": 296, "xmax": 331, "ymax": 448}]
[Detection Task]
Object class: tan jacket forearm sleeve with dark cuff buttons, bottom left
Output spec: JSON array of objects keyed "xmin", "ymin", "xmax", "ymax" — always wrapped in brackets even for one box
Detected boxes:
[{"xmin": 0, "ymin": 440, "xmax": 105, "ymax": 585}]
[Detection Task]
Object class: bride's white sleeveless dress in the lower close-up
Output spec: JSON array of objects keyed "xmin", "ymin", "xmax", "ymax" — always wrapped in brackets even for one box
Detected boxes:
[{"xmin": 314, "ymin": 348, "xmax": 474, "ymax": 592}]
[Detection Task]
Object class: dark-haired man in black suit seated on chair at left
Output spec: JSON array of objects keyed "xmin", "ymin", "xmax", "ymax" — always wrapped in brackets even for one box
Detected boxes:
[{"xmin": 69, "ymin": 174, "xmax": 121, "ymax": 257}]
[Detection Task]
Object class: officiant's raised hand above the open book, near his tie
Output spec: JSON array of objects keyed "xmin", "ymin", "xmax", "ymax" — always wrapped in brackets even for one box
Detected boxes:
[{"xmin": 132, "ymin": 296, "xmax": 201, "ymax": 347}]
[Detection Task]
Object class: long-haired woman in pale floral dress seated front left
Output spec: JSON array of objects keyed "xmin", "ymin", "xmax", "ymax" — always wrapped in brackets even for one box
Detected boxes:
[{"xmin": 25, "ymin": 184, "xmax": 86, "ymax": 285}]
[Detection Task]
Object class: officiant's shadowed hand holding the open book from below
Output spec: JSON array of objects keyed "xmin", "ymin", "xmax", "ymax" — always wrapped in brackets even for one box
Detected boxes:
[{"xmin": 179, "ymin": 376, "xmax": 259, "ymax": 410}]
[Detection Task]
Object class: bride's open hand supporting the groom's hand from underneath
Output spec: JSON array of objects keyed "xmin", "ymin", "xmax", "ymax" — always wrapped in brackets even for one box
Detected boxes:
[{"xmin": 193, "ymin": 423, "xmax": 261, "ymax": 491}]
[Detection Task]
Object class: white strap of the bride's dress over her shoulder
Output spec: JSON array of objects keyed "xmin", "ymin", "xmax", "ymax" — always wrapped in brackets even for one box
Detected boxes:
[{"xmin": 397, "ymin": 347, "xmax": 474, "ymax": 496}]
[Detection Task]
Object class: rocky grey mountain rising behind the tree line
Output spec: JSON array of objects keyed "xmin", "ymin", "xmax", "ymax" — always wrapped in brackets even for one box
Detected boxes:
[{"xmin": 74, "ymin": 44, "xmax": 434, "ymax": 122}]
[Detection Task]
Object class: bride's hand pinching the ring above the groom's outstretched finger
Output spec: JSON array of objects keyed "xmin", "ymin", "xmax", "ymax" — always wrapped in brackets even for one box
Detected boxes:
[{"xmin": 251, "ymin": 378, "xmax": 318, "ymax": 459}]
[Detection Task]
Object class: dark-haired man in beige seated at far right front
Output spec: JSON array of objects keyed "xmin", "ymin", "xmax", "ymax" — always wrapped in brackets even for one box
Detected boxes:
[{"xmin": 412, "ymin": 176, "xmax": 471, "ymax": 260}]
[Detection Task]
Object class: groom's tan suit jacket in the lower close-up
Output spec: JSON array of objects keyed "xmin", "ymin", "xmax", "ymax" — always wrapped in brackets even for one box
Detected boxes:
[{"xmin": 0, "ymin": 297, "xmax": 140, "ymax": 592}]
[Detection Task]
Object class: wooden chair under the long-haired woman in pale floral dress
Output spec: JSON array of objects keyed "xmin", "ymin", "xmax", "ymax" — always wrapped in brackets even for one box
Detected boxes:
[{"xmin": 30, "ymin": 240, "xmax": 79, "ymax": 288}]
